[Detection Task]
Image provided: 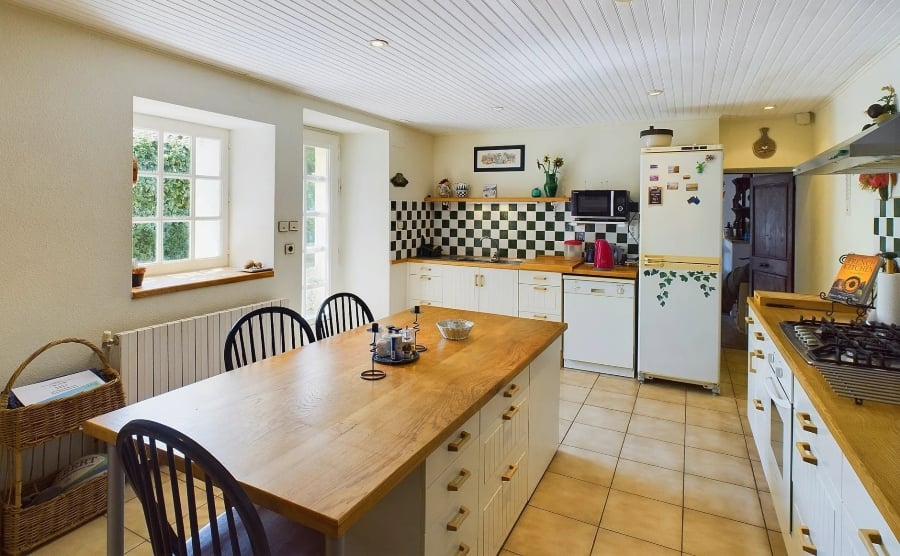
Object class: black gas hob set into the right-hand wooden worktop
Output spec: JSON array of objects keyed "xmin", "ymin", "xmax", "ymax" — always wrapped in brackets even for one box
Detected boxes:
[{"xmin": 781, "ymin": 317, "xmax": 900, "ymax": 405}]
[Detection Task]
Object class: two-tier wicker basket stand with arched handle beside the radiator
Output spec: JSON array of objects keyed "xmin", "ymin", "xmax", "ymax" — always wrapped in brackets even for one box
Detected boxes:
[{"xmin": 0, "ymin": 338, "xmax": 125, "ymax": 555}]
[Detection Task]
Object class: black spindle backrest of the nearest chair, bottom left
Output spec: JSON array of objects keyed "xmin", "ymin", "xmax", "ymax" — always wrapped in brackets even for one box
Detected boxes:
[{"xmin": 116, "ymin": 419, "xmax": 271, "ymax": 556}]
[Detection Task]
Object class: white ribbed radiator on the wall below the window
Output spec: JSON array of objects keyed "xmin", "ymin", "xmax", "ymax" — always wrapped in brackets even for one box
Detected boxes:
[{"xmin": 109, "ymin": 299, "xmax": 288, "ymax": 404}]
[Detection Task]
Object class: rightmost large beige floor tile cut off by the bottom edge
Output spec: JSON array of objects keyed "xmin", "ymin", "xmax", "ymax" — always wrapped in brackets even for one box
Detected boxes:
[{"xmin": 682, "ymin": 508, "xmax": 771, "ymax": 556}]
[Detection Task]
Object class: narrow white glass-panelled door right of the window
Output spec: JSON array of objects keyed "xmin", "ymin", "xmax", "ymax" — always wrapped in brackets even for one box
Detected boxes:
[{"xmin": 302, "ymin": 130, "xmax": 340, "ymax": 320}]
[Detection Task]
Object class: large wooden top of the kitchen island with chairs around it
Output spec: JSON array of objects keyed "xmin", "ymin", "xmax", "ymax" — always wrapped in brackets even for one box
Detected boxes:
[{"xmin": 84, "ymin": 307, "xmax": 566, "ymax": 537}]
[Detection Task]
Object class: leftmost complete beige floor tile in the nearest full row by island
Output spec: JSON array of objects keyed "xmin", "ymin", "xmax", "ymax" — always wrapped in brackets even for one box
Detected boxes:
[{"xmin": 528, "ymin": 472, "xmax": 609, "ymax": 525}]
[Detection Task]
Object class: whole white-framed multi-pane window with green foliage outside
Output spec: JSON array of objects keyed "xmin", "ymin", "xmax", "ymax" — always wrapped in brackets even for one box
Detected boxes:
[{"xmin": 131, "ymin": 114, "xmax": 229, "ymax": 274}]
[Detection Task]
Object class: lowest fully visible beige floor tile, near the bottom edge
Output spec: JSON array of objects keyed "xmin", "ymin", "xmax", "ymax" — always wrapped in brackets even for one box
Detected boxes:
[{"xmin": 600, "ymin": 490, "xmax": 682, "ymax": 554}]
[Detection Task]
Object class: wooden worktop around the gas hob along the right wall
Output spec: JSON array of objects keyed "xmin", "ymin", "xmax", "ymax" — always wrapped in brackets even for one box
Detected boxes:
[{"xmin": 750, "ymin": 292, "xmax": 900, "ymax": 538}]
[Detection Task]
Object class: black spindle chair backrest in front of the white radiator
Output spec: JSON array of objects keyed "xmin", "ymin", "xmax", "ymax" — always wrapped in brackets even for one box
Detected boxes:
[{"xmin": 225, "ymin": 307, "xmax": 316, "ymax": 371}]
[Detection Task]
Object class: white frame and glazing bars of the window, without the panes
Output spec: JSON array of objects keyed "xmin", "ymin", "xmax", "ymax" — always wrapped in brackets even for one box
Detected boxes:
[{"xmin": 131, "ymin": 113, "xmax": 231, "ymax": 275}]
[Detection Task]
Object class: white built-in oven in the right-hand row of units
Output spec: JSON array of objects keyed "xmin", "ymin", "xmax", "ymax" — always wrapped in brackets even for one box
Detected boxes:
[{"xmin": 754, "ymin": 353, "xmax": 793, "ymax": 531}]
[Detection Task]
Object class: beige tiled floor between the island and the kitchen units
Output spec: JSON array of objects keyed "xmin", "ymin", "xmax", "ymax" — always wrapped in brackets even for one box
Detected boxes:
[{"xmin": 34, "ymin": 349, "xmax": 786, "ymax": 556}]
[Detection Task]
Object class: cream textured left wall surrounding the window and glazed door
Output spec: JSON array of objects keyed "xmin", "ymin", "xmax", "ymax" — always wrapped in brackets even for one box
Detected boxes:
[{"xmin": 0, "ymin": 3, "xmax": 431, "ymax": 383}]
